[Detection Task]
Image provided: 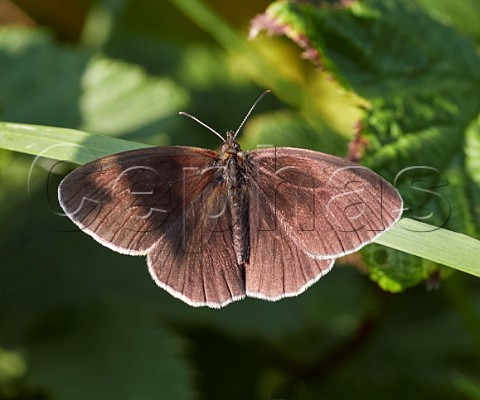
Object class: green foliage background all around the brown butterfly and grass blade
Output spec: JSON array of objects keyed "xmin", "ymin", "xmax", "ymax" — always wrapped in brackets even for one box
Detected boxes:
[{"xmin": 0, "ymin": 0, "xmax": 480, "ymax": 400}]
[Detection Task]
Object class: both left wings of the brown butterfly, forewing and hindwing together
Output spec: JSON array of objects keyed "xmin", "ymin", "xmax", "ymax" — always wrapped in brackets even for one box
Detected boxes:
[{"xmin": 59, "ymin": 147, "xmax": 245, "ymax": 307}]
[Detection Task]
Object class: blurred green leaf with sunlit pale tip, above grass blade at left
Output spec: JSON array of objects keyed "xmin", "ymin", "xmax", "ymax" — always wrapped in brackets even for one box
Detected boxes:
[{"xmin": 0, "ymin": 28, "xmax": 187, "ymax": 141}]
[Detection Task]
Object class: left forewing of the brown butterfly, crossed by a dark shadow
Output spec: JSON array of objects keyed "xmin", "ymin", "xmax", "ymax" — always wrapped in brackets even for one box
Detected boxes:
[{"xmin": 59, "ymin": 147, "xmax": 217, "ymax": 254}]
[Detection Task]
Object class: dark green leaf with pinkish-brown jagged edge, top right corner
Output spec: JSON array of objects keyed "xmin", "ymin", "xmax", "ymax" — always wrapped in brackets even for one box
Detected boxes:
[{"xmin": 254, "ymin": 0, "xmax": 480, "ymax": 99}]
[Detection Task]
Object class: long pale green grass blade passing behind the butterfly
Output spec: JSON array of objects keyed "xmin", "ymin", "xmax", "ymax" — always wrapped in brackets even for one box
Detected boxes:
[{"xmin": 0, "ymin": 122, "xmax": 480, "ymax": 277}]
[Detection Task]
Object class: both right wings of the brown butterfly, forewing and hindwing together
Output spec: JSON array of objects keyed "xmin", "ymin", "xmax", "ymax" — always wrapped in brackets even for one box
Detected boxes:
[{"xmin": 242, "ymin": 148, "xmax": 402, "ymax": 300}]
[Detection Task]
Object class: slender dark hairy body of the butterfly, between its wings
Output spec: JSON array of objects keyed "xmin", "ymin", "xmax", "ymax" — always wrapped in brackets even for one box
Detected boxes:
[{"xmin": 222, "ymin": 131, "xmax": 250, "ymax": 265}]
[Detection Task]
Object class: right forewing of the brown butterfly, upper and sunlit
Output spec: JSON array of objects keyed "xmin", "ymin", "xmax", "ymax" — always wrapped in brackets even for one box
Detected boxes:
[{"xmin": 247, "ymin": 148, "xmax": 403, "ymax": 260}]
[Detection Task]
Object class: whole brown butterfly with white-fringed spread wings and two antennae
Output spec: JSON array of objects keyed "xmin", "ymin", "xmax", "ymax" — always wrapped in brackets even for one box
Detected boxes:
[{"xmin": 58, "ymin": 91, "xmax": 403, "ymax": 308}]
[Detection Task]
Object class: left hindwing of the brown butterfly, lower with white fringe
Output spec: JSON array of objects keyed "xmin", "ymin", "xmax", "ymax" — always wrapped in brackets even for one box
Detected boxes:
[{"xmin": 147, "ymin": 179, "xmax": 245, "ymax": 308}]
